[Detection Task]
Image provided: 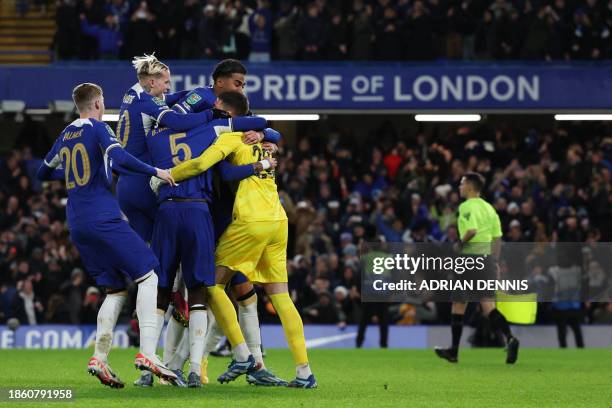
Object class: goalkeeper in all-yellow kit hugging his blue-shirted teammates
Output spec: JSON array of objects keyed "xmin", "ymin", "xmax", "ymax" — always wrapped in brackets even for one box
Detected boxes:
[{"xmin": 160, "ymin": 92, "xmax": 317, "ymax": 388}]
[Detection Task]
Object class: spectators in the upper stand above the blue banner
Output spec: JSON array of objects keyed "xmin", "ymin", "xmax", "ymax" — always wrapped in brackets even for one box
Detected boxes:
[{"xmin": 53, "ymin": 0, "xmax": 612, "ymax": 62}]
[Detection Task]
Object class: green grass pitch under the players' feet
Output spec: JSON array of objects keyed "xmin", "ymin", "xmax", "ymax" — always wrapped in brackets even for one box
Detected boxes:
[{"xmin": 0, "ymin": 349, "xmax": 612, "ymax": 408}]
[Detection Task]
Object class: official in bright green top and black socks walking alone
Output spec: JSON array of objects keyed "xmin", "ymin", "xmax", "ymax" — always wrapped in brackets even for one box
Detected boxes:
[{"xmin": 436, "ymin": 173, "xmax": 519, "ymax": 364}]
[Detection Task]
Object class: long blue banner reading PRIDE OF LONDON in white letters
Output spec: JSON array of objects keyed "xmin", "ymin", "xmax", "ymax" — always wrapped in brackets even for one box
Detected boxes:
[{"xmin": 0, "ymin": 61, "xmax": 612, "ymax": 112}]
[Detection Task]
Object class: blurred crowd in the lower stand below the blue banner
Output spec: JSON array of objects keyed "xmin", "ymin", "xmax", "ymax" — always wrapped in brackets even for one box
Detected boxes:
[{"xmin": 0, "ymin": 116, "xmax": 612, "ymax": 340}]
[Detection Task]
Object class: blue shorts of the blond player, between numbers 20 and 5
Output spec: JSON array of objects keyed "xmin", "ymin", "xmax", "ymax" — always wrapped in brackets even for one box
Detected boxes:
[{"xmin": 117, "ymin": 175, "xmax": 157, "ymax": 242}]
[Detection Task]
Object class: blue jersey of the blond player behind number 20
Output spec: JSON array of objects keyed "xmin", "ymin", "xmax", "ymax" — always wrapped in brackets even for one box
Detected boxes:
[{"xmin": 116, "ymin": 84, "xmax": 170, "ymax": 164}]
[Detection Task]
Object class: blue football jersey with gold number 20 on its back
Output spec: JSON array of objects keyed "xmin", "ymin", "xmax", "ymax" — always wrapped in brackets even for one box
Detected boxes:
[{"xmin": 45, "ymin": 119, "xmax": 121, "ymax": 224}]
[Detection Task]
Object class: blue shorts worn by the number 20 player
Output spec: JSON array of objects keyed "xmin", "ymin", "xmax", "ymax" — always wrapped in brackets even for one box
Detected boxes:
[{"xmin": 70, "ymin": 218, "xmax": 159, "ymax": 289}]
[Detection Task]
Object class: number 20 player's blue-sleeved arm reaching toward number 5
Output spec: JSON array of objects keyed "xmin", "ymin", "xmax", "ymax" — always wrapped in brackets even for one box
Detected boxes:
[{"xmin": 96, "ymin": 124, "xmax": 174, "ymax": 184}]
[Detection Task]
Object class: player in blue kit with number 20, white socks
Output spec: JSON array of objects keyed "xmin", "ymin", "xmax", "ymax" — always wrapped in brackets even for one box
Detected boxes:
[{"xmin": 37, "ymin": 83, "xmax": 176, "ymax": 388}]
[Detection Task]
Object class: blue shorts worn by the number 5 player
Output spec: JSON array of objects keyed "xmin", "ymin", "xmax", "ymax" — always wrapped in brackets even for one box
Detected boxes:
[{"xmin": 151, "ymin": 201, "xmax": 215, "ymax": 289}]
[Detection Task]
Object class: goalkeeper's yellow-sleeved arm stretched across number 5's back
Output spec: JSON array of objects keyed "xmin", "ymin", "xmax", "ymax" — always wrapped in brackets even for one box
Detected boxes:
[{"xmin": 170, "ymin": 132, "xmax": 242, "ymax": 181}]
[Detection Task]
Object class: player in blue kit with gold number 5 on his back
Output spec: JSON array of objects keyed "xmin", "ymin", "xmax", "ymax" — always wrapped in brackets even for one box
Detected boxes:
[{"xmin": 147, "ymin": 103, "xmax": 271, "ymax": 387}]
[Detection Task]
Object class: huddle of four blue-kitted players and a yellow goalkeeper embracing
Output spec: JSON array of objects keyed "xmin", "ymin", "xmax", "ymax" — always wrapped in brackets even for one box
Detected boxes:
[{"xmin": 37, "ymin": 55, "xmax": 317, "ymax": 388}]
